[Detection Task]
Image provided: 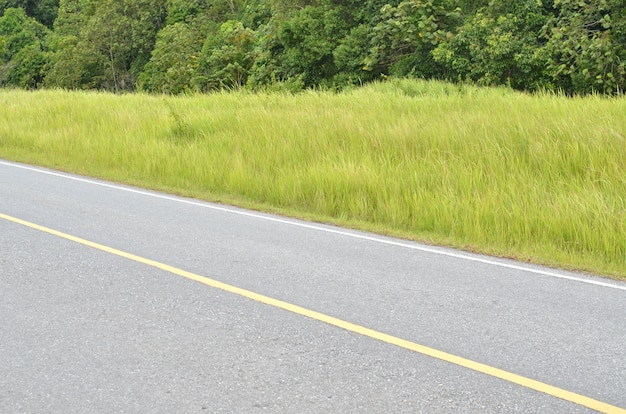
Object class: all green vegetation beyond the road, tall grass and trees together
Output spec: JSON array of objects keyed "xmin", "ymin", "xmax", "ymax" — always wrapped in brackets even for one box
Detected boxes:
[{"xmin": 0, "ymin": 0, "xmax": 626, "ymax": 276}]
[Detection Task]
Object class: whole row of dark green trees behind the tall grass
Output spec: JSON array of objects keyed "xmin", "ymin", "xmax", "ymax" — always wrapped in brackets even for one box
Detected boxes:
[{"xmin": 0, "ymin": 0, "xmax": 626, "ymax": 94}]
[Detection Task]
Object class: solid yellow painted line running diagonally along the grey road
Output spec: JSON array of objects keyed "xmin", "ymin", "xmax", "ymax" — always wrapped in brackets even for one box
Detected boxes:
[{"xmin": 0, "ymin": 213, "xmax": 626, "ymax": 414}]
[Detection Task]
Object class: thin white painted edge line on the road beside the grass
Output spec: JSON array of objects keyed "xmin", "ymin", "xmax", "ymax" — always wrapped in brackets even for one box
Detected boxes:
[{"xmin": 0, "ymin": 161, "xmax": 626, "ymax": 291}]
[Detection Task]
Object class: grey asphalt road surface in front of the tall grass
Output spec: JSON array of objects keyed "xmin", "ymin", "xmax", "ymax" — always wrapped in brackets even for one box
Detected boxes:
[{"xmin": 0, "ymin": 161, "xmax": 626, "ymax": 413}]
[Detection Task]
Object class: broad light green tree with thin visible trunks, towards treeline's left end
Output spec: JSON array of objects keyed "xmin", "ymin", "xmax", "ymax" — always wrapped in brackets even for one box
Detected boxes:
[{"xmin": 46, "ymin": 0, "xmax": 165, "ymax": 92}]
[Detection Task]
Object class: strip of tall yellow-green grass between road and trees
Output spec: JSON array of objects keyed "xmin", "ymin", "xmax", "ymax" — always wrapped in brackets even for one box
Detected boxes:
[{"xmin": 0, "ymin": 81, "xmax": 626, "ymax": 278}]
